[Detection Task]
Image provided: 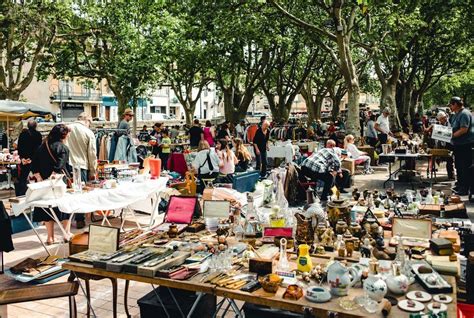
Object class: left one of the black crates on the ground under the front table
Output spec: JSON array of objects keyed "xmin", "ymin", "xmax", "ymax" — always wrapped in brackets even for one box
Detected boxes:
[{"xmin": 137, "ymin": 287, "xmax": 216, "ymax": 318}]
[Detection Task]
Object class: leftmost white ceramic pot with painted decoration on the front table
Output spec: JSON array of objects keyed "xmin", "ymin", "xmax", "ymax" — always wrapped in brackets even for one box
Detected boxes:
[{"xmin": 328, "ymin": 261, "xmax": 357, "ymax": 296}]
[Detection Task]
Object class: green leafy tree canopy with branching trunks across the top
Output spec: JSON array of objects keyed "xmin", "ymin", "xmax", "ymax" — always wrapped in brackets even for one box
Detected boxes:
[{"xmin": 0, "ymin": 0, "xmax": 474, "ymax": 126}]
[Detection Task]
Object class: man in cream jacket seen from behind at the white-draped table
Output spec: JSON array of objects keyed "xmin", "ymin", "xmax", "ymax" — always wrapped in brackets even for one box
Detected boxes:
[{"xmin": 66, "ymin": 113, "xmax": 97, "ymax": 229}]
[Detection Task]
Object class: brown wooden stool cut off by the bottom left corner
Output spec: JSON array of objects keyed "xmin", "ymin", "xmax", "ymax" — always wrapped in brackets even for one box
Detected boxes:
[{"xmin": 0, "ymin": 282, "xmax": 79, "ymax": 318}]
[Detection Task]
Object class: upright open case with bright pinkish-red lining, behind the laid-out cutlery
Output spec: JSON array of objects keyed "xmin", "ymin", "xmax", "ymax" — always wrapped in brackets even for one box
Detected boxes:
[{"xmin": 165, "ymin": 196, "xmax": 201, "ymax": 224}]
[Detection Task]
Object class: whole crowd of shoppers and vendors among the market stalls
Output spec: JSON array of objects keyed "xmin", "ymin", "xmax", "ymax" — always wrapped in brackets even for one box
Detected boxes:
[{"xmin": 10, "ymin": 97, "xmax": 474, "ymax": 244}]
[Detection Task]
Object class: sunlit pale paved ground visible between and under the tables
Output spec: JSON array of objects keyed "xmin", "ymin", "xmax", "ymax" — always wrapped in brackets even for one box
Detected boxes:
[{"xmin": 5, "ymin": 160, "xmax": 474, "ymax": 318}]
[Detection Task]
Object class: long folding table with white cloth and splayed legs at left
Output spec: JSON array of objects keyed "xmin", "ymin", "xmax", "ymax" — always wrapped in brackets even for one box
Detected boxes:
[{"xmin": 12, "ymin": 177, "xmax": 168, "ymax": 254}]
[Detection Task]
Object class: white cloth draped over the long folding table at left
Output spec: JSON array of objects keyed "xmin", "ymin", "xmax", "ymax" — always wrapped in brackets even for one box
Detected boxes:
[{"xmin": 12, "ymin": 177, "xmax": 168, "ymax": 215}]
